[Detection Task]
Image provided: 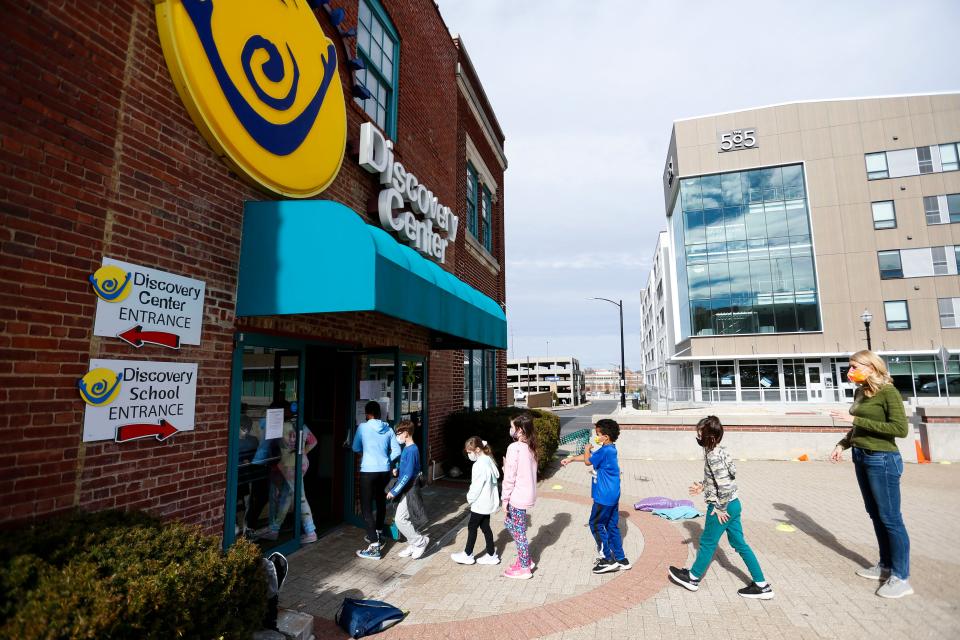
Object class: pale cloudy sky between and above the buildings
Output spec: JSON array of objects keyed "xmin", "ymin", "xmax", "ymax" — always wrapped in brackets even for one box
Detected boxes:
[{"xmin": 437, "ymin": 0, "xmax": 960, "ymax": 369}]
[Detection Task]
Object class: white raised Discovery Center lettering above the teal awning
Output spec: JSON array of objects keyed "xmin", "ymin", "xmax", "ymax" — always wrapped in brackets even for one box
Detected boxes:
[{"xmin": 360, "ymin": 122, "xmax": 460, "ymax": 263}]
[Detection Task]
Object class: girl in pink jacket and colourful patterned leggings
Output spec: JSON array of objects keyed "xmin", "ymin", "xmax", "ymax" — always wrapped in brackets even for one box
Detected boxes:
[{"xmin": 500, "ymin": 413, "xmax": 537, "ymax": 580}]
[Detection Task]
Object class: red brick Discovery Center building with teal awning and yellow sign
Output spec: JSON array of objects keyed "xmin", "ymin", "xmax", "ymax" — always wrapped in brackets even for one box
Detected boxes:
[{"xmin": 0, "ymin": 0, "xmax": 507, "ymax": 551}]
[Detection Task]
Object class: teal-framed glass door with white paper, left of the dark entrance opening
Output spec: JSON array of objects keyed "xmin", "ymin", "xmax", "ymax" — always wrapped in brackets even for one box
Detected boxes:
[{"xmin": 224, "ymin": 342, "xmax": 302, "ymax": 550}]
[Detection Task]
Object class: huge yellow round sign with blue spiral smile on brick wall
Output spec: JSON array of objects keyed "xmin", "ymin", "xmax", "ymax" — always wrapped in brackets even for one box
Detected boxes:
[{"xmin": 156, "ymin": 0, "xmax": 347, "ymax": 198}]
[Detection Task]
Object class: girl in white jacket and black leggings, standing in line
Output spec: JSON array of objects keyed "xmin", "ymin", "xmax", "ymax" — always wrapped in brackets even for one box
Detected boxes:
[{"xmin": 450, "ymin": 436, "xmax": 500, "ymax": 564}]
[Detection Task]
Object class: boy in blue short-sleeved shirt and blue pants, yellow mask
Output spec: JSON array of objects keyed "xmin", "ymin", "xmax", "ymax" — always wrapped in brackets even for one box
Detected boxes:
[{"xmin": 584, "ymin": 418, "xmax": 633, "ymax": 573}]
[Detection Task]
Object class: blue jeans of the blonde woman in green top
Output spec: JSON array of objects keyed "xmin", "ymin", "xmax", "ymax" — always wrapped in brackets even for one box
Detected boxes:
[{"xmin": 853, "ymin": 447, "xmax": 910, "ymax": 580}]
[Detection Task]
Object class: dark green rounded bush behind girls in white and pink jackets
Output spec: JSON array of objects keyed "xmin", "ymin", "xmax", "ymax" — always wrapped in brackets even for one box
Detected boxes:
[{"xmin": 444, "ymin": 407, "xmax": 560, "ymax": 475}]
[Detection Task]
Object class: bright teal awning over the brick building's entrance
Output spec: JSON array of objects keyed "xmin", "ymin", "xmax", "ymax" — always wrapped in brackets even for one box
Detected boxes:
[{"xmin": 237, "ymin": 200, "xmax": 507, "ymax": 349}]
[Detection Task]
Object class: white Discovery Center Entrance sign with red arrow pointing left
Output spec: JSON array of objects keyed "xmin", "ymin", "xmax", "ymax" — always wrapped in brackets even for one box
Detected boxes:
[{"xmin": 90, "ymin": 258, "xmax": 206, "ymax": 349}]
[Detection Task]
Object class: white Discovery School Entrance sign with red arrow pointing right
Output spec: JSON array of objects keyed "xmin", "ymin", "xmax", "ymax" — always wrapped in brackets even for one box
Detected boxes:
[{"xmin": 77, "ymin": 359, "xmax": 197, "ymax": 442}]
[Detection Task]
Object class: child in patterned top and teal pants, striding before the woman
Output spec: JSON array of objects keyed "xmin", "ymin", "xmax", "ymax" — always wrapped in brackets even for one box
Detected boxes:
[{"xmin": 669, "ymin": 416, "xmax": 773, "ymax": 600}]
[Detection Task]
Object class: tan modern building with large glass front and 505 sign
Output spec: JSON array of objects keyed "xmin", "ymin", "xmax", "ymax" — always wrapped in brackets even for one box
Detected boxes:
[{"xmin": 663, "ymin": 93, "xmax": 960, "ymax": 402}]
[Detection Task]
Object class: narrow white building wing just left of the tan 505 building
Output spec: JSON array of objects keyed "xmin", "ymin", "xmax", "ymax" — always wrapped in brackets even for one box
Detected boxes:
[{"xmin": 640, "ymin": 231, "xmax": 674, "ymax": 393}]
